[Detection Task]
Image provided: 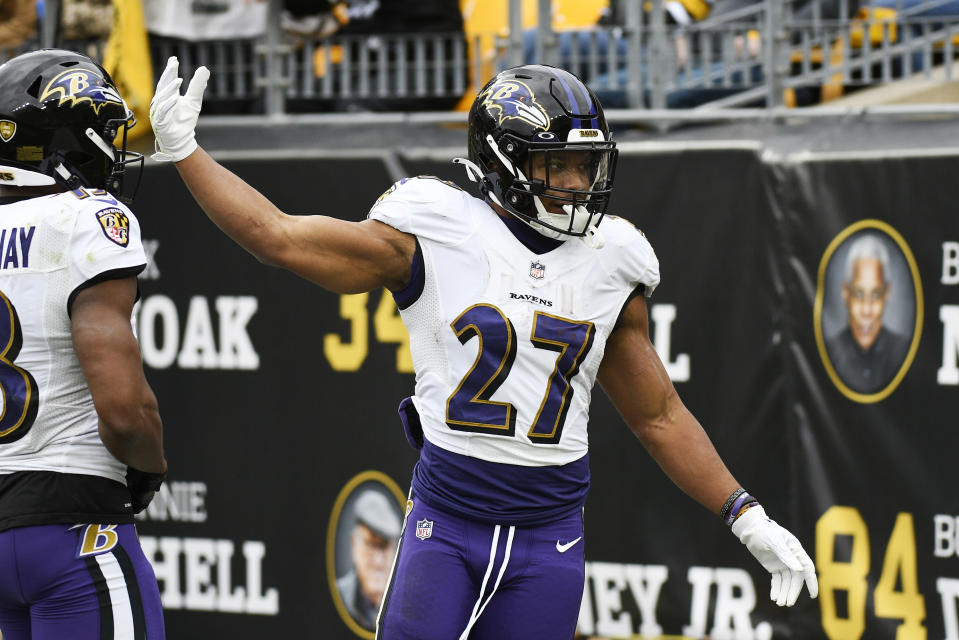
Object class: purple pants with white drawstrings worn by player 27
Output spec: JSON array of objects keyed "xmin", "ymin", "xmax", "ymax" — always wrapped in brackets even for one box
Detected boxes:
[{"xmin": 376, "ymin": 498, "xmax": 585, "ymax": 640}]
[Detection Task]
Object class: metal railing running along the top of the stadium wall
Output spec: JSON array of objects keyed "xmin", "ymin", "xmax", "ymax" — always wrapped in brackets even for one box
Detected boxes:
[{"xmin": 1, "ymin": 0, "xmax": 959, "ymax": 117}]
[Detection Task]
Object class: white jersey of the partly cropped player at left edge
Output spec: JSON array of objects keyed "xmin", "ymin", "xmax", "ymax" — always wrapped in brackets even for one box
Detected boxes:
[{"xmin": 0, "ymin": 189, "xmax": 146, "ymax": 486}]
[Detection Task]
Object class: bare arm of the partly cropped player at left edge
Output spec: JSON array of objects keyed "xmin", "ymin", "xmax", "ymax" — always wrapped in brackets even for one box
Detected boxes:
[{"xmin": 71, "ymin": 277, "xmax": 166, "ymax": 473}]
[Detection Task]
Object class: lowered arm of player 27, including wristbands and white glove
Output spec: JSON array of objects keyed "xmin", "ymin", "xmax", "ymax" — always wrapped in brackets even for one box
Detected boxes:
[{"xmin": 598, "ymin": 296, "xmax": 819, "ymax": 606}]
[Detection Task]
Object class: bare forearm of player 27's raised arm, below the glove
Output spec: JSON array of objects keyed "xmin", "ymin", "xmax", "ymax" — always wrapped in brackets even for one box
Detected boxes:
[{"xmin": 176, "ymin": 148, "xmax": 286, "ymax": 264}]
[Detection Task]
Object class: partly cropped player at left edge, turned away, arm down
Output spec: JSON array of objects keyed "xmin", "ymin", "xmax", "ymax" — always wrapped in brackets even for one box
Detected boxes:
[{"xmin": 0, "ymin": 49, "xmax": 166, "ymax": 640}]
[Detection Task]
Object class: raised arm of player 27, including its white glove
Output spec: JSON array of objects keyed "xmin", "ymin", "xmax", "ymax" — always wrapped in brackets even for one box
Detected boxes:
[{"xmin": 150, "ymin": 58, "xmax": 416, "ymax": 293}]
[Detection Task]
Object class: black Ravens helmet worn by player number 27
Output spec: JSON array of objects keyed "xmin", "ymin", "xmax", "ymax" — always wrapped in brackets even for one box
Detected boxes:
[{"xmin": 468, "ymin": 65, "xmax": 617, "ymax": 238}]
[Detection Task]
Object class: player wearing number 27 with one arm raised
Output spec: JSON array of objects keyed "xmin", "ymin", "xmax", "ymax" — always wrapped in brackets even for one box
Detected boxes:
[{"xmin": 150, "ymin": 58, "xmax": 818, "ymax": 640}]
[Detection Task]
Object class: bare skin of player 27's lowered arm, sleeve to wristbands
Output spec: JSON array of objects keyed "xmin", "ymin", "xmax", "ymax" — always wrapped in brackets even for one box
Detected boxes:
[{"xmin": 598, "ymin": 296, "xmax": 739, "ymax": 514}]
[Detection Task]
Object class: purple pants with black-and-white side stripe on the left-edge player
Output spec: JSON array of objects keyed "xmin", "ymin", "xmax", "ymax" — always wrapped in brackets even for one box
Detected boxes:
[{"xmin": 0, "ymin": 524, "xmax": 164, "ymax": 640}]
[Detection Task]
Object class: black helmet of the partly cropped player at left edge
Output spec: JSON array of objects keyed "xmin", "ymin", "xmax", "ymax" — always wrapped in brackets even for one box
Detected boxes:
[{"xmin": 0, "ymin": 49, "xmax": 143, "ymax": 202}]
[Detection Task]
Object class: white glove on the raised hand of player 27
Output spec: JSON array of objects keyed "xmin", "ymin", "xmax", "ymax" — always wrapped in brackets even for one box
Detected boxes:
[{"xmin": 150, "ymin": 56, "xmax": 210, "ymax": 162}]
